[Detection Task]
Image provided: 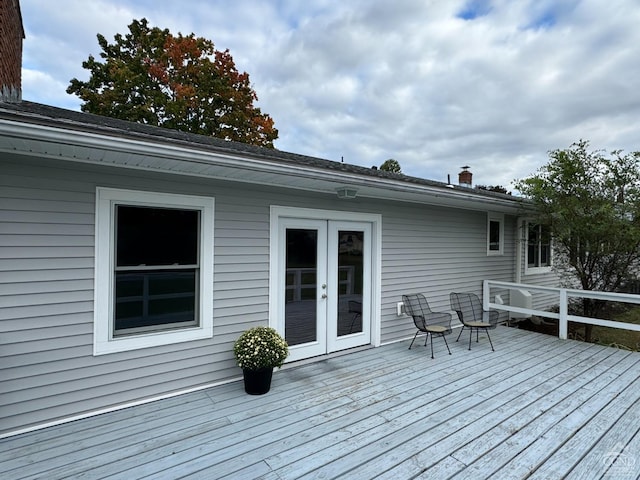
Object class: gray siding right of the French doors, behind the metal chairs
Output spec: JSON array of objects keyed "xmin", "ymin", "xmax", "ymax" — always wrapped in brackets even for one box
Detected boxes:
[{"xmin": 381, "ymin": 204, "xmax": 515, "ymax": 343}]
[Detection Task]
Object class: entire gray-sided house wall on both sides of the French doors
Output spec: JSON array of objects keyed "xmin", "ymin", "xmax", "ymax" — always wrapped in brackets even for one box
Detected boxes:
[{"xmin": 0, "ymin": 155, "xmax": 515, "ymax": 434}]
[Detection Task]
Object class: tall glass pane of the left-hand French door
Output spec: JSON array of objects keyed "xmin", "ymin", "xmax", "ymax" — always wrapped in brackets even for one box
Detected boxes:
[{"xmin": 284, "ymin": 228, "xmax": 318, "ymax": 345}]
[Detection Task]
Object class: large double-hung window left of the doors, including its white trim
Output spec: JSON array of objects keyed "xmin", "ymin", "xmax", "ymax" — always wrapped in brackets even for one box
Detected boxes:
[{"xmin": 94, "ymin": 188, "xmax": 213, "ymax": 354}]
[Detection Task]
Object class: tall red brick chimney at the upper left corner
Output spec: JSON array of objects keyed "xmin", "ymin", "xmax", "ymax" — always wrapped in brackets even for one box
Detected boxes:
[{"xmin": 0, "ymin": 0, "xmax": 24, "ymax": 102}]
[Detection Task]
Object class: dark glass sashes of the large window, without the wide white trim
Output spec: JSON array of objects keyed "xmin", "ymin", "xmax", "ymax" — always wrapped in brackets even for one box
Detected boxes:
[{"xmin": 113, "ymin": 205, "xmax": 200, "ymax": 336}]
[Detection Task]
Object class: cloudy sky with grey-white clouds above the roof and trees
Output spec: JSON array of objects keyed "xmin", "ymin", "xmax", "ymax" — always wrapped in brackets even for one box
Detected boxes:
[{"xmin": 21, "ymin": 0, "xmax": 640, "ymax": 186}]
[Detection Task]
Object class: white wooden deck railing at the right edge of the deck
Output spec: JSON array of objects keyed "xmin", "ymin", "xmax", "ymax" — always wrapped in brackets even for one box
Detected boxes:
[{"xmin": 482, "ymin": 280, "xmax": 640, "ymax": 340}]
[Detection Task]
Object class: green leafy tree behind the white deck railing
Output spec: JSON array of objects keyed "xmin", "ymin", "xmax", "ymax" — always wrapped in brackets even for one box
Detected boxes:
[{"xmin": 516, "ymin": 140, "xmax": 640, "ymax": 341}]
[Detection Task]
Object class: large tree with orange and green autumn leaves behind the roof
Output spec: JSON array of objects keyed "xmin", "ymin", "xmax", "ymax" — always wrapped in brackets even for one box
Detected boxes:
[{"xmin": 67, "ymin": 18, "xmax": 278, "ymax": 147}]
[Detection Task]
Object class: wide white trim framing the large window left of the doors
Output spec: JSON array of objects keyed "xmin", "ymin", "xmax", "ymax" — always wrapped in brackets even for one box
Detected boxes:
[{"xmin": 93, "ymin": 187, "xmax": 215, "ymax": 355}]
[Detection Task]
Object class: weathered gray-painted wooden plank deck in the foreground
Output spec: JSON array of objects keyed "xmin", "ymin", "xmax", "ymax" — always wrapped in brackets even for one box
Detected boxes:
[{"xmin": 0, "ymin": 327, "xmax": 640, "ymax": 480}]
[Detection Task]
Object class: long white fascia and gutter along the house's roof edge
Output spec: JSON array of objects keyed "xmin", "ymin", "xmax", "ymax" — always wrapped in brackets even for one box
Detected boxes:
[{"xmin": 0, "ymin": 119, "xmax": 526, "ymax": 213}]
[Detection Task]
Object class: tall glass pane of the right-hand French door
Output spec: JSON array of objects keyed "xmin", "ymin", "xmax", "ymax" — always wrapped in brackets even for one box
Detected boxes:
[{"xmin": 337, "ymin": 230, "xmax": 364, "ymax": 337}]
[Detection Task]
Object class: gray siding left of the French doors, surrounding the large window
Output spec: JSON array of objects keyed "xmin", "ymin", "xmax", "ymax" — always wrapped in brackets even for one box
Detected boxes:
[{"xmin": 0, "ymin": 158, "xmax": 278, "ymax": 432}]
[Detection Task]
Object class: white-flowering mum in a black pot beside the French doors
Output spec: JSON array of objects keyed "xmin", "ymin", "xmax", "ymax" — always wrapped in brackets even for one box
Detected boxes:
[{"xmin": 233, "ymin": 327, "xmax": 289, "ymax": 395}]
